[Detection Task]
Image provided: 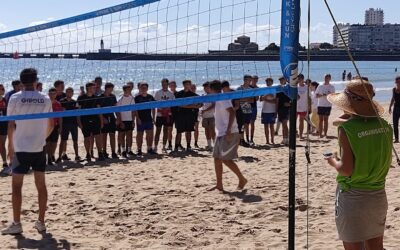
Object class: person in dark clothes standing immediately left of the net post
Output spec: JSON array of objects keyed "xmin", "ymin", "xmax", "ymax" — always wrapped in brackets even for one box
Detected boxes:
[{"xmin": 275, "ymin": 76, "xmax": 291, "ymax": 145}]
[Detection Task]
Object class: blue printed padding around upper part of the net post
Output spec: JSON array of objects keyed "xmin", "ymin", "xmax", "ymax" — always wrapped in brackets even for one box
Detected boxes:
[{"xmin": 280, "ymin": 0, "xmax": 300, "ymax": 99}]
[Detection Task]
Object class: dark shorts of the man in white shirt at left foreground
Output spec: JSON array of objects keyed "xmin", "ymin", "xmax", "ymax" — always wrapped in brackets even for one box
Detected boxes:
[{"xmin": 11, "ymin": 150, "xmax": 46, "ymax": 174}]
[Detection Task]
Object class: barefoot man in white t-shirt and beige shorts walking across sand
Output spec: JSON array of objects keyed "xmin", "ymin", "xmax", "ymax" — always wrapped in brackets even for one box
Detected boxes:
[{"xmin": 210, "ymin": 80, "xmax": 247, "ymax": 191}]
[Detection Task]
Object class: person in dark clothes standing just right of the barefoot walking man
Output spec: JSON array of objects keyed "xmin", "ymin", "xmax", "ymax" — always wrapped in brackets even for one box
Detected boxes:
[{"xmin": 237, "ymin": 75, "xmax": 254, "ymax": 146}]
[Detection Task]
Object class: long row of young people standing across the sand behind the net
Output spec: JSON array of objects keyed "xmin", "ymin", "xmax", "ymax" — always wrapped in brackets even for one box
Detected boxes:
[{"xmin": 0, "ymin": 70, "xmax": 400, "ymax": 178}]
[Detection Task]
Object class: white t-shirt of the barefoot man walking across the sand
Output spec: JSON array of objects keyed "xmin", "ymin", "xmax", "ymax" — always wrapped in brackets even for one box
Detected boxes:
[{"xmin": 214, "ymin": 100, "xmax": 239, "ymax": 137}]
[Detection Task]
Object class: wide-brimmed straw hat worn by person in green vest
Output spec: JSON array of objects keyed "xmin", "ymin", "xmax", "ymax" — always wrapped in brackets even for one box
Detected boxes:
[{"xmin": 328, "ymin": 78, "xmax": 385, "ymax": 117}]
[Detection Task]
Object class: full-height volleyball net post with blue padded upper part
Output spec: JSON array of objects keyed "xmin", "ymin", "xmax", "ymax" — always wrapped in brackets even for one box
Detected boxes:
[{"xmin": 280, "ymin": 0, "xmax": 300, "ymax": 250}]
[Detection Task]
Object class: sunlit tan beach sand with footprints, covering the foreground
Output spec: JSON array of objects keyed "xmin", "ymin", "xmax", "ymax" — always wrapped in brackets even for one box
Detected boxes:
[{"xmin": 0, "ymin": 104, "xmax": 400, "ymax": 250}]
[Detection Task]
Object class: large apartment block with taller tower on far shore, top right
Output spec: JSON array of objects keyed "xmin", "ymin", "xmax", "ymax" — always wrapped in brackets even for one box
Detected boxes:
[{"xmin": 333, "ymin": 9, "xmax": 400, "ymax": 51}]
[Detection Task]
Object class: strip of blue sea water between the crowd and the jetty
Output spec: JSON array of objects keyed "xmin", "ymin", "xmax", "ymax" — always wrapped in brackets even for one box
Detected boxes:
[{"xmin": 0, "ymin": 58, "xmax": 400, "ymax": 102}]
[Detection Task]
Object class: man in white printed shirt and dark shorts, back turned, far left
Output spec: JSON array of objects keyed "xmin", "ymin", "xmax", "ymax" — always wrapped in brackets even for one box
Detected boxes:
[{"xmin": 1, "ymin": 68, "xmax": 54, "ymax": 235}]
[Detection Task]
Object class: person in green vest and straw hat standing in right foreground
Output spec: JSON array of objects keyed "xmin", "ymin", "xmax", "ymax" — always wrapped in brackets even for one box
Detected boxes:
[{"xmin": 325, "ymin": 78, "xmax": 393, "ymax": 249}]
